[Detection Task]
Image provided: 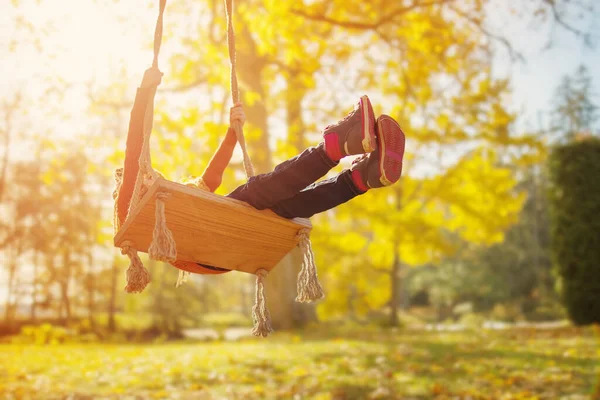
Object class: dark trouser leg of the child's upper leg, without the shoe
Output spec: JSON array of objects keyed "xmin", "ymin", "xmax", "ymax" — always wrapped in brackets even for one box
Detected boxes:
[{"xmin": 227, "ymin": 143, "xmax": 338, "ymax": 210}]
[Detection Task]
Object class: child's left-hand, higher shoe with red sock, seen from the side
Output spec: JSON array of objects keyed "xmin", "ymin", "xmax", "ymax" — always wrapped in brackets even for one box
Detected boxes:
[{"xmin": 323, "ymin": 96, "xmax": 377, "ymax": 161}]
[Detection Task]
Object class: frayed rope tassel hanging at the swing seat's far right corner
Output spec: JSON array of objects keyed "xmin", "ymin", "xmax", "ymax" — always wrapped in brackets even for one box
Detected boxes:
[{"xmin": 296, "ymin": 228, "xmax": 325, "ymax": 303}]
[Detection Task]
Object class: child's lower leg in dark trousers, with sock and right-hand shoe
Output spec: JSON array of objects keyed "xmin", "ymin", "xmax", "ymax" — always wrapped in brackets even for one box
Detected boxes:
[{"xmin": 270, "ymin": 115, "xmax": 405, "ymax": 218}]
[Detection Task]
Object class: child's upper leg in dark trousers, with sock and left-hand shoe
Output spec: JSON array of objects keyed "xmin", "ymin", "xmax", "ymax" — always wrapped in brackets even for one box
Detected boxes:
[{"xmin": 228, "ymin": 96, "xmax": 375, "ymax": 210}]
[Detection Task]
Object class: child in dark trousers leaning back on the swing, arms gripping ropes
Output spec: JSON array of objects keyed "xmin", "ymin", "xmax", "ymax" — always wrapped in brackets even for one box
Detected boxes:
[{"xmin": 117, "ymin": 69, "xmax": 405, "ymax": 270}]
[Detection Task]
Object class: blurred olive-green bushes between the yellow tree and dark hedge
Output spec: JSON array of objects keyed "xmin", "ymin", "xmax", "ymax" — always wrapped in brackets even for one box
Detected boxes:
[{"xmin": 409, "ymin": 171, "xmax": 562, "ymax": 320}]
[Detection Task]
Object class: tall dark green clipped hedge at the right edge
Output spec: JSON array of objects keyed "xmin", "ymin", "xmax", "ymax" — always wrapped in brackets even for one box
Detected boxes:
[{"xmin": 549, "ymin": 138, "xmax": 600, "ymax": 325}]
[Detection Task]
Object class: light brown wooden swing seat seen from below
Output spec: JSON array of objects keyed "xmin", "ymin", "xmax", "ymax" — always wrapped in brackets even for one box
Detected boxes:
[{"xmin": 114, "ymin": 178, "xmax": 312, "ymax": 273}]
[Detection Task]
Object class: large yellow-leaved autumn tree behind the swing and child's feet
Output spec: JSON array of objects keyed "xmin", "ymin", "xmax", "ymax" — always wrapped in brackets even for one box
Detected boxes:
[{"xmin": 130, "ymin": 1, "xmax": 556, "ymax": 326}]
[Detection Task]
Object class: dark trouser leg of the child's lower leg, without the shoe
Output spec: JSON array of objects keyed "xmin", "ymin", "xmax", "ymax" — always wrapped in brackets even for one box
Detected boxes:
[{"xmin": 270, "ymin": 170, "xmax": 364, "ymax": 218}]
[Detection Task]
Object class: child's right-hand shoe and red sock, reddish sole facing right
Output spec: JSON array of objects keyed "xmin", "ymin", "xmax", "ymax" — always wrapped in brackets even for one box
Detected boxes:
[{"xmin": 351, "ymin": 115, "xmax": 405, "ymax": 191}]
